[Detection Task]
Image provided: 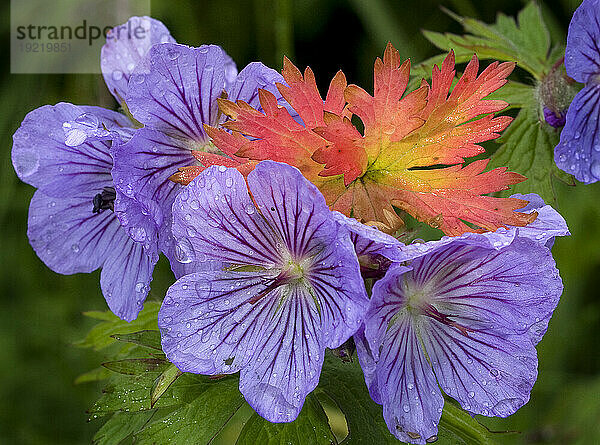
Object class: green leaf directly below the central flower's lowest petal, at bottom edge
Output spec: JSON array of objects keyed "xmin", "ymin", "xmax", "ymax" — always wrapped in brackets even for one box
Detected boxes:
[{"xmin": 236, "ymin": 394, "xmax": 337, "ymax": 445}]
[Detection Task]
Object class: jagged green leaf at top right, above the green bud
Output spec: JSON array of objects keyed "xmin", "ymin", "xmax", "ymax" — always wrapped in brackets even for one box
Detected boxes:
[{"xmin": 417, "ymin": 1, "xmax": 555, "ymax": 79}]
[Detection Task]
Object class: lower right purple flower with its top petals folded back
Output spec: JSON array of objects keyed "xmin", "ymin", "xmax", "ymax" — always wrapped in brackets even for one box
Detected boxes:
[{"xmin": 338, "ymin": 194, "xmax": 568, "ymax": 444}]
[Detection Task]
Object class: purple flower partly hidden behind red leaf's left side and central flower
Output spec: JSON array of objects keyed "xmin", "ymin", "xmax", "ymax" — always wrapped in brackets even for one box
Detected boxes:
[{"xmin": 113, "ymin": 43, "xmax": 296, "ymax": 276}]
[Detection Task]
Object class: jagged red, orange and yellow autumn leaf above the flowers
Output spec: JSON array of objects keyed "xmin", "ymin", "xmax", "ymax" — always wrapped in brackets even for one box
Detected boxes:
[{"xmin": 209, "ymin": 44, "xmax": 535, "ymax": 235}]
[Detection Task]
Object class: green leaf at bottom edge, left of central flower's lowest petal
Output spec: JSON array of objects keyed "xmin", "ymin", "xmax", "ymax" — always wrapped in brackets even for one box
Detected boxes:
[{"xmin": 135, "ymin": 375, "xmax": 245, "ymax": 445}]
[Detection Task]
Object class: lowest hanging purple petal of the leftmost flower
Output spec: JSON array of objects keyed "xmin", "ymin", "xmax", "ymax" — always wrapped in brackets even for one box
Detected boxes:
[{"xmin": 100, "ymin": 227, "xmax": 158, "ymax": 321}]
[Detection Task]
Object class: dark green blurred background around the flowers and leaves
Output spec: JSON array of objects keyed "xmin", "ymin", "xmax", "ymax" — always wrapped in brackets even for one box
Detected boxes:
[{"xmin": 0, "ymin": 0, "xmax": 600, "ymax": 444}]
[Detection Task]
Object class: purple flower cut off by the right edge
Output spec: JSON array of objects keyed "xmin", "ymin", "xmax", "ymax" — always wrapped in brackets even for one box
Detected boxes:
[{"xmin": 554, "ymin": 0, "xmax": 600, "ymax": 184}]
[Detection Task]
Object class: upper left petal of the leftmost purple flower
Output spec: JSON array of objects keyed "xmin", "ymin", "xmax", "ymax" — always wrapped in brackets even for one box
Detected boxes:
[{"xmin": 12, "ymin": 103, "xmax": 129, "ymax": 197}]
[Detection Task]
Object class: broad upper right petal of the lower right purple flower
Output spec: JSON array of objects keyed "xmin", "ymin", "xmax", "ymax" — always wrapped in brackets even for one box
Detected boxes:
[{"xmin": 411, "ymin": 238, "xmax": 563, "ymax": 343}]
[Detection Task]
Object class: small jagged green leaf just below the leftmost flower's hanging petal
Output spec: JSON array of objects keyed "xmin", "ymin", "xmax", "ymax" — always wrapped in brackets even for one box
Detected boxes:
[{"xmin": 76, "ymin": 301, "xmax": 160, "ymax": 350}]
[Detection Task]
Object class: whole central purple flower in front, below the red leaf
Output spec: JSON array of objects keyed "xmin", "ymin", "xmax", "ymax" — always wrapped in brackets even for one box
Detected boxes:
[{"xmin": 158, "ymin": 161, "xmax": 368, "ymax": 422}]
